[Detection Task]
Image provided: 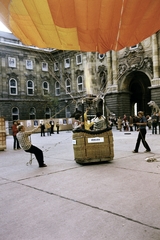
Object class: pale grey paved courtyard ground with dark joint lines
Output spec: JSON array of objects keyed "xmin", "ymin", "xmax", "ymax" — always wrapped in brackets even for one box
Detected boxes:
[{"xmin": 0, "ymin": 129, "xmax": 160, "ymax": 240}]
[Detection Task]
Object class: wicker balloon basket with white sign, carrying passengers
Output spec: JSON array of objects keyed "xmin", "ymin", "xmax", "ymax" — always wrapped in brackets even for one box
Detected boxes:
[{"xmin": 72, "ymin": 129, "xmax": 114, "ymax": 163}]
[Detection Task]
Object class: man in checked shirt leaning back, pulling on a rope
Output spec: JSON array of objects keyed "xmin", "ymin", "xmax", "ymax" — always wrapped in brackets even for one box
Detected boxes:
[{"xmin": 16, "ymin": 125, "xmax": 47, "ymax": 168}]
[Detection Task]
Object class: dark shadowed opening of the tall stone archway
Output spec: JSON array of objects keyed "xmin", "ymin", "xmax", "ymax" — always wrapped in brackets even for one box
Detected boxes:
[{"xmin": 126, "ymin": 71, "xmax": 151, "ymax": 115}]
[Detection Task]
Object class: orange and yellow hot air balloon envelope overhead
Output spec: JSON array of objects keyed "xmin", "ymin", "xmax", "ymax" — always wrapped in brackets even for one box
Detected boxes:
[{"xmin": 0, "ymin": 0, "xmax": 160, "ymax": 53}]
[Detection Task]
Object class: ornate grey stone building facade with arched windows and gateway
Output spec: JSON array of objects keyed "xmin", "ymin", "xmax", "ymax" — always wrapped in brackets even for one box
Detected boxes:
[{"xmin": 0, "ymin": 32, "xmax": 160, "ymax": 121}]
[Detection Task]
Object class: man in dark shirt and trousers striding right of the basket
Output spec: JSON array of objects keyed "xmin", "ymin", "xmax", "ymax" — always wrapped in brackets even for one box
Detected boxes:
[{"xmin": 133, "ymin": 111, "xmax": 151, "ymax": 153}]
